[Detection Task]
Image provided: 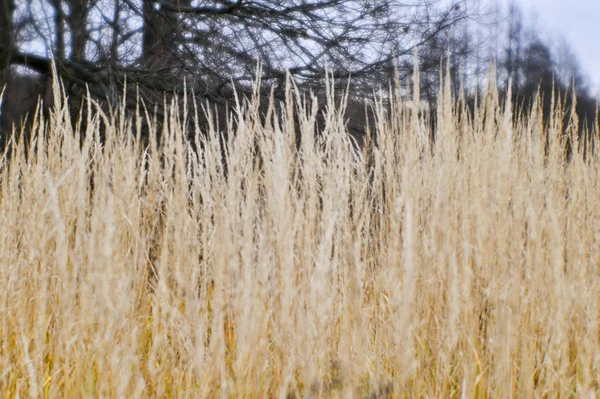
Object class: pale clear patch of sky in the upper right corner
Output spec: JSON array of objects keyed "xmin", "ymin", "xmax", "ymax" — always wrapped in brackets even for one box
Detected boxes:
[{"xmin": 492, "ymin": 0, "xmax": 600, "ymax": 96}]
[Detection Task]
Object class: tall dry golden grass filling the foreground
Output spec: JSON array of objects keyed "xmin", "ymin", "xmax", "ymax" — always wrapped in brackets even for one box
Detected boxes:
[{"xmin": 0, "ymin": 74, "xmax": 600, "ymax": 398}]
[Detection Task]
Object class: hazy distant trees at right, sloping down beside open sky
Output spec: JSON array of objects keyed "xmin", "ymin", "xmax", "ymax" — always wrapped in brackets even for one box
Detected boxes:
[{"xmin": 421, "ymin": 1, "xmax": 598, "ymax": 134}]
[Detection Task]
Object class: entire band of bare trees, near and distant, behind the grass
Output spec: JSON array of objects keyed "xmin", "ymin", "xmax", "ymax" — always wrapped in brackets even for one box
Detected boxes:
[{"xmin": 0, "ymin": 0, "xmax": 597, "ymax": 147}]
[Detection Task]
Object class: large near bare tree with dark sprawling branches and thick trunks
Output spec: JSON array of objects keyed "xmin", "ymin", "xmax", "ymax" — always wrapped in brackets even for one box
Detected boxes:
[{"xmin": 0, "ymin": 0, "xmax": 468, "ymax": 106}]
